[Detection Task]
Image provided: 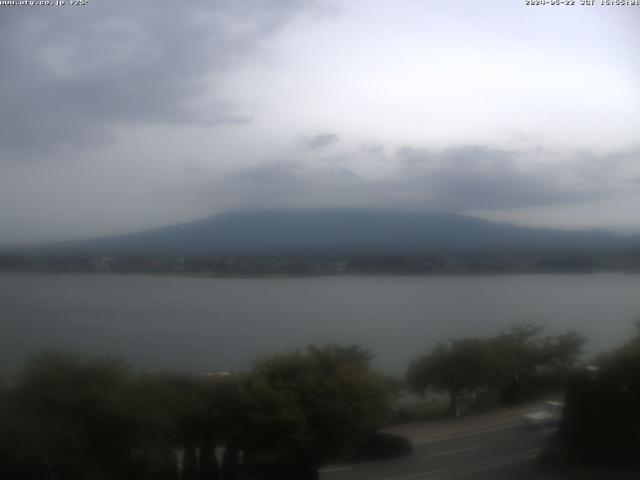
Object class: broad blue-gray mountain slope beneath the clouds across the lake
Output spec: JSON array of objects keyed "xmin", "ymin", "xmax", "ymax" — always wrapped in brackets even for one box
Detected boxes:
[{"xmin": 11, "ymin": 209, "xmax": 640, "ymax": 256}]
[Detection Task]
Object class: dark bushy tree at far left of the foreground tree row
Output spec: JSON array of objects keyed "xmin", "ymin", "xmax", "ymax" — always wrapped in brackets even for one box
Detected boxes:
[{"xmin": 7, "ymin": 353, "xmax": 134, "ymax": 480}]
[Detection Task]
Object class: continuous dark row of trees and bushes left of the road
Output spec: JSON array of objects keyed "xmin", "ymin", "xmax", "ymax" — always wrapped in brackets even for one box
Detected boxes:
[{"xmin": 0, "ymin": 345, "xmax": 390, "ymax": 480}]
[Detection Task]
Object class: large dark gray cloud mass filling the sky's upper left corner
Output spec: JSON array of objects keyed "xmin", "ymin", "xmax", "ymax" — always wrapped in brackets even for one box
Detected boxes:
[{"xmin": 0, "ymin": 0, "xmax": 314, "ymax": 159}]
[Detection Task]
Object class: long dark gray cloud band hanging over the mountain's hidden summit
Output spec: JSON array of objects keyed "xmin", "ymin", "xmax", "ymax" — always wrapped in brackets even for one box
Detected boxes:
[{"xmin": 201, "ymin": 146, "xmax": 637, "ymax": 212}]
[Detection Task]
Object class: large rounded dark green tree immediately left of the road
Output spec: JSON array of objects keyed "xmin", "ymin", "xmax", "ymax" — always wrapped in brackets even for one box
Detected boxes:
[{"xmin": 240, "ymin": 345, "xmax": 389, "ymax": 474}]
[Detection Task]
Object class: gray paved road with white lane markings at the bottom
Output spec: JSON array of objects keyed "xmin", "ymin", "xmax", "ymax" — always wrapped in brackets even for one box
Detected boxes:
[{"xmin": 320, "ymin": 424, "xmax": 554, "ymax": 480}]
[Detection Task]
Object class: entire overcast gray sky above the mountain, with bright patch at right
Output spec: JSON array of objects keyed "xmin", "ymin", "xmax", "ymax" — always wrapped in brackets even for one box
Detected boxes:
[{"xmin": 0, "ymin": 0, "xmax": 640, "ymax": 244}]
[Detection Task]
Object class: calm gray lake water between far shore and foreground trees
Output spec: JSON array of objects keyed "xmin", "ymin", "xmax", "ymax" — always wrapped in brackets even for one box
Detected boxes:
[{"xmin": 0, "ymin": 274, "xmax": 640, "ymax": 374}]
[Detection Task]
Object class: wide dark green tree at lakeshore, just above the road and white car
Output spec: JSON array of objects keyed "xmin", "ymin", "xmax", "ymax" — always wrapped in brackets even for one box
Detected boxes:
[{"xmin": 406, "ymin": 323, "xmax": 585, "ymax": 415}]
